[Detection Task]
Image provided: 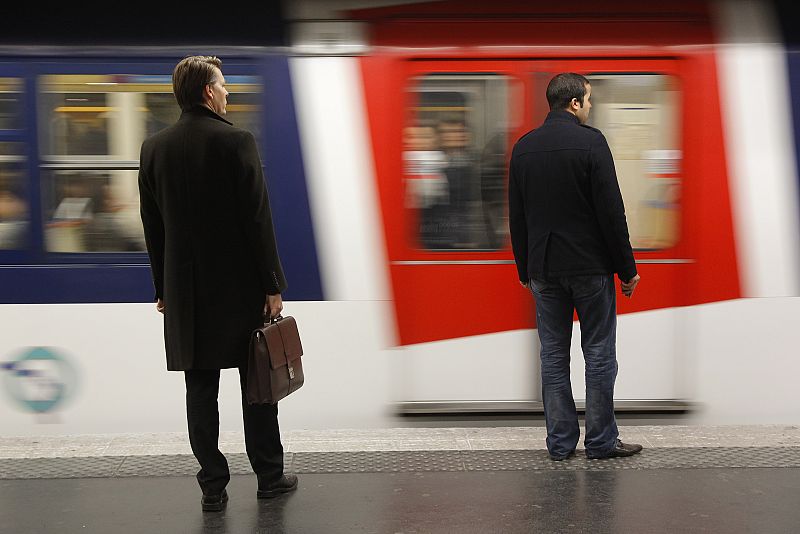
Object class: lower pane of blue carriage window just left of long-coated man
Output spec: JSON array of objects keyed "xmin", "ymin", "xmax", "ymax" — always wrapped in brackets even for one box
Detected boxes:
[{"xmin": 42, "ymin": 170, "xmax": 145, "ymax": 252}]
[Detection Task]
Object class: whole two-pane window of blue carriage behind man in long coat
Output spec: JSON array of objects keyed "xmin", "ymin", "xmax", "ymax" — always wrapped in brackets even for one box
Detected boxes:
[{"xmin": 39, "ymin": 74, "xmax": 262, "ymax": 253}]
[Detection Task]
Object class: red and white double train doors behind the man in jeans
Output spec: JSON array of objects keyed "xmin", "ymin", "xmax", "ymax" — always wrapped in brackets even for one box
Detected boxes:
[{"xmin": 373, "ymin": 57, "xmax": 712, "ymax": 412}]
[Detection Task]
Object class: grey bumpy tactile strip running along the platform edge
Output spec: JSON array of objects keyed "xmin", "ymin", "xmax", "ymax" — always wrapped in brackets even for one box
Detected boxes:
[{"xmin": 0, "ymin": 447, "xmax": 800, "ymax": 479}]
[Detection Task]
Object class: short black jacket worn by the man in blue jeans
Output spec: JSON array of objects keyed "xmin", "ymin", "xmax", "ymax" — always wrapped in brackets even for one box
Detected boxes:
[{"xmin": 508, "ymin": 111, "xmax": 636, "ymax": 282}]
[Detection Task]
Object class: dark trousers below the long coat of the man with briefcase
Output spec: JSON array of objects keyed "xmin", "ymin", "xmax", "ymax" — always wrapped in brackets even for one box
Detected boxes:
[{"xmin": 184, "ymin": 367, "xmax": 283, "ymax": 495}]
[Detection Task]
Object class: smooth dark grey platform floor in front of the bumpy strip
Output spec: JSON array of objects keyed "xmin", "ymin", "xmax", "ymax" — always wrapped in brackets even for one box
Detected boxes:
[{"xmin": 0, "ymin": 469, "xmax": 800, "ymax": 534}]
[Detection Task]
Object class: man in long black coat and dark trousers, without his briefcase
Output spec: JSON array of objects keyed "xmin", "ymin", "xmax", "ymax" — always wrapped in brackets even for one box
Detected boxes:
[{"xmin": 139, "ymin": 56, "xmax": 297, "ymax": 511}]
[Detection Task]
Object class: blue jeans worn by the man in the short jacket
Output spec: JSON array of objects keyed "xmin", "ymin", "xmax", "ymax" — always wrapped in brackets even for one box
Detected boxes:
[{"xmin": 531, "ymin": 274, "xmax": 619, "ymax": 457}]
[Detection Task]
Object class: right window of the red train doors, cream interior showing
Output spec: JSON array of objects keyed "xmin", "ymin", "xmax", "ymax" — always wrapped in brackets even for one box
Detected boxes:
[{"xmin": 588, "ymin": 74, "xmax": 681, "ymax": 250}]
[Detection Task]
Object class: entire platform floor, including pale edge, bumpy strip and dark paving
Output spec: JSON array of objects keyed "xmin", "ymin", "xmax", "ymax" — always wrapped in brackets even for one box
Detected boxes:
[{"xmin": 0, "ymin": 425, "xmax": 800, "ymax": 533}]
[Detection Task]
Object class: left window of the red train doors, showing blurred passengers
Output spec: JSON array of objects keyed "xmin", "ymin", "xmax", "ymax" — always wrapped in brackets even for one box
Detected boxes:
[{"xmin": 403, "ymin": 74, "xmax": 509, "ymax": 250}]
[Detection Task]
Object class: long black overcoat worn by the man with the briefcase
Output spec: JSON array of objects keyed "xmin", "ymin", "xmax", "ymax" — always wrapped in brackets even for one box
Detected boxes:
[{"xmin": 139, "ymin": 107, "xmax": 286, "ymax": 371}]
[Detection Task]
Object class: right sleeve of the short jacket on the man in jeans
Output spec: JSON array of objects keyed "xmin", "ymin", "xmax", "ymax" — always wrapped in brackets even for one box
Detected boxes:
[{"xmin": 590, "ymin": 134, "xmax": 636, "ymax": 282}]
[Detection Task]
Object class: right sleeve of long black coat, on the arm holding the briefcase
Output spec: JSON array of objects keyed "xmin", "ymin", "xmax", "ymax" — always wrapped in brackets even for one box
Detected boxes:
[{"xmin": 237, "ymin": 132, "xmax": 286, "ymax": 295}]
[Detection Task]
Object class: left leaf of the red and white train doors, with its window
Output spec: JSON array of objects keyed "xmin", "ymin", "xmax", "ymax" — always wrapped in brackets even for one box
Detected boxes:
[{"xmin": 379, "ymin": 61, "xmax": 537, "ymax": 402}]
